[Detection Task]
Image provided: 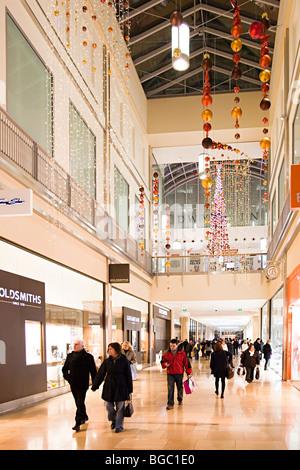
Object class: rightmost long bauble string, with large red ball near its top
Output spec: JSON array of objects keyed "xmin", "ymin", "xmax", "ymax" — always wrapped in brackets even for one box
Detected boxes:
[{"xmin": 249, "ymin": 12, "xmax": 271, "ymax": 203}]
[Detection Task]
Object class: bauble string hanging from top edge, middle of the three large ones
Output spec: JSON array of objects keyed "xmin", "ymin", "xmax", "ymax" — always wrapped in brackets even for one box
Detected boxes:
[{"xmin": 230, "ymin": 1, "xmax": 243, "ymax": 140}]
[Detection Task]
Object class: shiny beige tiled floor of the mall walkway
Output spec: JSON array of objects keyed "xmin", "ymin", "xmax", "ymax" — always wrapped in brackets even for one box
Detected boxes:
[{"xmin": 0, "ymin": 358, "xmax": 300, "ymax": 451}]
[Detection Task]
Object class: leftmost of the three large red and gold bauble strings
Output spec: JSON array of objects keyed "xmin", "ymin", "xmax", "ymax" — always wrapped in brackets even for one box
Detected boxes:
[{"xmin": 201, "ymin": 54, "xmax": 213, "ymax": 229}]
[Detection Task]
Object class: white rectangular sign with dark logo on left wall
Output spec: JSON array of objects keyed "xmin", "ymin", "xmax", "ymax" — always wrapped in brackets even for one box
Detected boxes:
[{"xmin": 0, "ymin": 189, "xmax": 33, "ymax": 217}]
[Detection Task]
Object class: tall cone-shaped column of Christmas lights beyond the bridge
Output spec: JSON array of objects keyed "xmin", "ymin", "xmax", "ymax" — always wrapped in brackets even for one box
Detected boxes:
[{"xmin": 207, "ymin": 165, "xmax": 230, "ymax": 256}]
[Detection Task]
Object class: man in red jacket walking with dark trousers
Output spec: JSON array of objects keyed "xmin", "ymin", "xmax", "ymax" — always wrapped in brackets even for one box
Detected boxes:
[{"xmin": 161, "ymin": 339, "xmax": 192, "ymax": 410}]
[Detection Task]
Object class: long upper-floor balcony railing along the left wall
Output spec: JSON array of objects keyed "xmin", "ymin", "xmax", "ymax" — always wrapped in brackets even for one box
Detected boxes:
[{"xmin": 0, "ymin": 108, "xmax": 152, "ymax": 274}]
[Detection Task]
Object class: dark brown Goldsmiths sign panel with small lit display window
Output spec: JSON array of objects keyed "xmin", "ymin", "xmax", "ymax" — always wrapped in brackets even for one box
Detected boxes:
[{"xmin": 0, "ymin": 270, "xmax": 47, "ymax": 403}]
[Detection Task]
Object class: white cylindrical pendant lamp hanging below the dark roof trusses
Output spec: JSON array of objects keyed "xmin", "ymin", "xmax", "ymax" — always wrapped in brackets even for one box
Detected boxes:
[{"xmin": 170, "ymin": 11, "xmax": 190, "ymax": 72}]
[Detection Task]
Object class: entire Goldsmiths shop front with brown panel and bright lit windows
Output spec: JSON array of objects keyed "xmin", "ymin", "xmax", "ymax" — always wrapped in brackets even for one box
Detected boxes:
[{"xmin": 0, "ymin": 241, "xmax": 104, "ymax": 403}]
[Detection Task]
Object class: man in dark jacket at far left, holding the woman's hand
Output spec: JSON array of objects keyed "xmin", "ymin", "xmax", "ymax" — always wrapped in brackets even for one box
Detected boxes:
[{"xmin": 62, "ymin": 339, "xmax": 97, "ymax": 432}]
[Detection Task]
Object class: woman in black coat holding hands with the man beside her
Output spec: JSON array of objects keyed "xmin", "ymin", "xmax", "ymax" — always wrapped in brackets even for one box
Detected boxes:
[{"xmin": 92, "ymin": 343, "xmax": 132, "ymax": 432}]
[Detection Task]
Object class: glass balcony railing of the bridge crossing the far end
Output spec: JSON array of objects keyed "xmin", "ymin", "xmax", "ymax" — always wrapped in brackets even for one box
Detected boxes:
[{"xmin": 152, "ymin": 253, "xmax": 267, "ymax": 275}]
